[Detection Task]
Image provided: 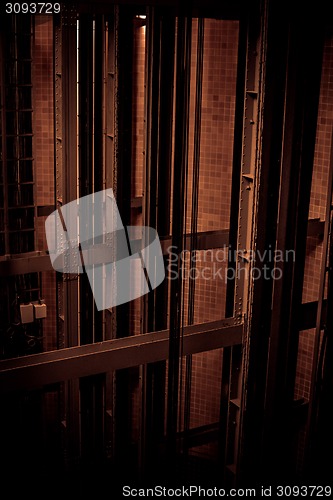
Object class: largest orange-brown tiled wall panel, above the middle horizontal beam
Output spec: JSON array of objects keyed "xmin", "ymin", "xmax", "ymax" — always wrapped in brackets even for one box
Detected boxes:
[{"xmin": 198, "ymin": 19, "xmax": 238, "ymax": 231}]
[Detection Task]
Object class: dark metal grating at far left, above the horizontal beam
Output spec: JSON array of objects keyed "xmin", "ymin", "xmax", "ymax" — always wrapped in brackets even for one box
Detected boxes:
[{"xmin": 0, "ymin": 16, "xmax": 35, "ymax": 255}]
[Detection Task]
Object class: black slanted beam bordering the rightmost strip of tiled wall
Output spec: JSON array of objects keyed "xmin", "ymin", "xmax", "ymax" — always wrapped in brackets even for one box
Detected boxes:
[{"xmin": 264, "ymin": 4, "xmax": 327, "ymax": 478}]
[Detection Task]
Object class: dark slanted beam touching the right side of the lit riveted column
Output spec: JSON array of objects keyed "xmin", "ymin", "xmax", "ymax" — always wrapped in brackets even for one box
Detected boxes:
[{"xmin": 239, "ymin": 3, "xmax": 288, "ymax": 482}]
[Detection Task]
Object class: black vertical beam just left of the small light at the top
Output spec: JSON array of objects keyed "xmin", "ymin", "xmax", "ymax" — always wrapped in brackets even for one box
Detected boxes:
[{"xmin": 114, "ymin": 6, "xmax": 135, "ymax": 480}]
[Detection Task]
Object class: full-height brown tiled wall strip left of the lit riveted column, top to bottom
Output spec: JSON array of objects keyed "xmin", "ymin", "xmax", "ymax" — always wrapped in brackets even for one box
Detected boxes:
[{"xmin": 188, "ymin": 19, "xmax": 238, "ymax": 455}]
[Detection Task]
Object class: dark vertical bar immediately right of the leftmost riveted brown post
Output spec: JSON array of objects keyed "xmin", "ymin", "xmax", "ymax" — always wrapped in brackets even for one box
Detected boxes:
[{"xmin": 78, "ymin": 14, "xmax": 104, "ymax": 461}]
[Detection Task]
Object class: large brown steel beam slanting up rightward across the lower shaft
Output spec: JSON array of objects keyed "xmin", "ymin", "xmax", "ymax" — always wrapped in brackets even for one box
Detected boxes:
[{"xmin": 0, "ymin": 319, "xmax": 243, "ymax": 392}]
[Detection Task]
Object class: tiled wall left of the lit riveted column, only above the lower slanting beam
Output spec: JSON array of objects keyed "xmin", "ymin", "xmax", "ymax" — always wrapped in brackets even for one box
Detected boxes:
[{"xmin": 187, "ymin": 19, "xmax": 238, "ymax": 323}]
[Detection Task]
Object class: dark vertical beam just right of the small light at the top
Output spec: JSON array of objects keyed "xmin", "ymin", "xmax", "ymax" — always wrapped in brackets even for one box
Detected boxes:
[{"xmin": 141, "ymin": 8, "xmax": 175, "ymax": 477}]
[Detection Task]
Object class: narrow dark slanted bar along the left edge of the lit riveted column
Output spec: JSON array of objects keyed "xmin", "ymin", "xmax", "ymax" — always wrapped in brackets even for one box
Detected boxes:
[{"xmin": 219, "ymin": 4, "xmax": 250, "ymax": 481}]
